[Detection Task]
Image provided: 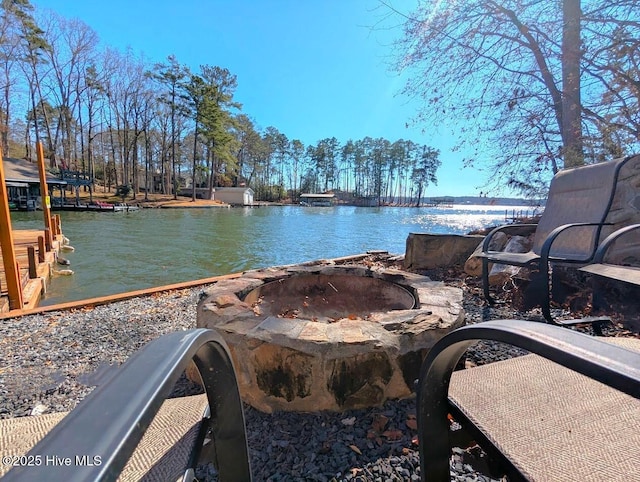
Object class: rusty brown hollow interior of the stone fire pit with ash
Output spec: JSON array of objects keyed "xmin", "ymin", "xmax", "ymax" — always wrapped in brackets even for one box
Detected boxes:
[{"xmin": 244, "ymin": 274, "xmax": 416, "ymax": 322}]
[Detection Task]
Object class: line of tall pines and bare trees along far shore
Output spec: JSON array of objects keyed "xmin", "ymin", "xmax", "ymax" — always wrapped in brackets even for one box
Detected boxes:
[{"xmin": 0, "ymin": 0, "xmax": 441, "ymax": 203}]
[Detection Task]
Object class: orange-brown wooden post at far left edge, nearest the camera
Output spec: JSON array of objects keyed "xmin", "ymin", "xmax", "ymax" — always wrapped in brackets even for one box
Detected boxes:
[{"xmin": 0, "ymin": 154, "xmax": 23, "ymax": 310}]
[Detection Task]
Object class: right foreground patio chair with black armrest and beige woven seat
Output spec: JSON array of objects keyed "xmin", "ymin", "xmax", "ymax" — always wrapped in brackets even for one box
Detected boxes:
[{"xmin": 417, "ymin": 320, "xmax": 640, "ymax": 481}]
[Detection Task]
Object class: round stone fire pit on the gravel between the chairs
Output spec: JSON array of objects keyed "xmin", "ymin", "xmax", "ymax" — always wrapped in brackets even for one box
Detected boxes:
[{"xmin": 198, "ymin": 263, "xmax": 464, "ymax": 412}]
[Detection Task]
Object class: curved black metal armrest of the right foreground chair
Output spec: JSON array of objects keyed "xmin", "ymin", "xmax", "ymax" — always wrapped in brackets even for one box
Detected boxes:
[{"xmin": 417, "ymin": 320, "xmax": 640, "ymax": 481}]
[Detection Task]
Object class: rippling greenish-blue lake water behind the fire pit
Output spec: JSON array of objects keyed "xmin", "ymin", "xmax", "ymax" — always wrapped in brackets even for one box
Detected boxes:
[{"xmin": 12, "ymin": 205, "xmax": 531, "ymax": 305}]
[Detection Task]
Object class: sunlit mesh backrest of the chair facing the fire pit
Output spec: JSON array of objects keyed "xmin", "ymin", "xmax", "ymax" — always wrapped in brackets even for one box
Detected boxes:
[{"xmin": 532, "ymin": 157, "xmax": 632, "ymax": 259}]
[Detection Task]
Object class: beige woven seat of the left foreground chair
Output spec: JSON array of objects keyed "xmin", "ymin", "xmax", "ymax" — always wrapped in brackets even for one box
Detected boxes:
[{"xmin": 0, "ymin": 395, "xmax": 207, "ymax": 481}]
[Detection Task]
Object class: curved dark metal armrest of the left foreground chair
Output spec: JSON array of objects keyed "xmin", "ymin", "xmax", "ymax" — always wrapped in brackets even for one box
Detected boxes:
[{"xmin": 5, "ymin": 329, "xmax": 251, "ymax": 481}]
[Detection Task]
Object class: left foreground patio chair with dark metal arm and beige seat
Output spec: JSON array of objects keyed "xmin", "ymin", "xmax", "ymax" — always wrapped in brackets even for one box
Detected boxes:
[{"xmin": 0, "ymin": 329, "xmax": 251, "ymax": 481}]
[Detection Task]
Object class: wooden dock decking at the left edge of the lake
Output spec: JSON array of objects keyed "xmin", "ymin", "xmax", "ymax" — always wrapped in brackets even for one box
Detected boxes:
[{"xmin": 0, "ymin": 229, "xmax": 62, "ymax": 313}]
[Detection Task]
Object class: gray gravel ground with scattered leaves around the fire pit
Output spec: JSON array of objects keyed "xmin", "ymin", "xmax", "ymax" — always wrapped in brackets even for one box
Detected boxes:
[{"xmin": 0, "ymin": 262, "xmax": 636, "ymax": 481}]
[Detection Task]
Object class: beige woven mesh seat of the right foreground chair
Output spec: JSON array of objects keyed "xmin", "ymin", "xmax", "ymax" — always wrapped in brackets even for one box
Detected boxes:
[{"xmin": 449, "ymin": 338, "xmax": 640, "ymax": 482}]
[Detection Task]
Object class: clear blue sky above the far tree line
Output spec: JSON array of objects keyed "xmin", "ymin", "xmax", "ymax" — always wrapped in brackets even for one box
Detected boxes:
[{"xmin": 32, "ymin": 0, "xmax": 490, "ymax": 196}]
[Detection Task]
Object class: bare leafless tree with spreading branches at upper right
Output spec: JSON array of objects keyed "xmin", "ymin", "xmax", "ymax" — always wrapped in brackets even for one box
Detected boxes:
[{"xmin": 390, "ymin": 0, "xmax": 638, "ymax": 196}]
